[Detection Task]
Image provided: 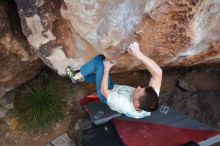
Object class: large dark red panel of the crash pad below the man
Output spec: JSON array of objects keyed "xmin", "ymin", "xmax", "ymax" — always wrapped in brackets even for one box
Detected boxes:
[{"xmin": 113, "ymin": 119, "xmax": 220, "ymax": 146}]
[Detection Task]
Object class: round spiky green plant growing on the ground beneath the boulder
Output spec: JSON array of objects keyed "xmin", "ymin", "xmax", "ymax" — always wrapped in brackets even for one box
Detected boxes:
[{"xmin": 14, "ymin": 78, "xmax": 66, "ymax": 132}]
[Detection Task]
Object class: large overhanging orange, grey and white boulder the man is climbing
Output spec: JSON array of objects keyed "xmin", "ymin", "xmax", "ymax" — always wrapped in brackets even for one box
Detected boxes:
[{"xmin": 15, "ymin": 0, "xmax": 220, "ymax": 74}]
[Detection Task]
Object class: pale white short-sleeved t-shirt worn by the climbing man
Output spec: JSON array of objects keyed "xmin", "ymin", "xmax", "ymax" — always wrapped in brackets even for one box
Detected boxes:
[{"xmin": 107, "ymin": 85, "xmax": 159, "ymax": 118}]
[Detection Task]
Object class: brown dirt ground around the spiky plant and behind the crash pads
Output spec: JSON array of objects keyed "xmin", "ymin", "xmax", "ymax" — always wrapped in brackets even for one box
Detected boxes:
[{"xmin": 0, "ymin": 65, "xmax": 220, "ymax": 146}]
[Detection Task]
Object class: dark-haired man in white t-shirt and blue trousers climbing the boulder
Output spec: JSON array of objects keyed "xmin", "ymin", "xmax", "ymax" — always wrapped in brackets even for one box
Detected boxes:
[{"xmin": 66, "ymin": 42, "xmax": 162, "ymax": 118}]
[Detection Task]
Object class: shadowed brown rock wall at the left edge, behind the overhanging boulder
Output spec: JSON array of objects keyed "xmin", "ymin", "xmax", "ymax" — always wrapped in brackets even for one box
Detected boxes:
[{"xmin": 0, "ymin": 1, "xmax": 44, "ymax": 99}]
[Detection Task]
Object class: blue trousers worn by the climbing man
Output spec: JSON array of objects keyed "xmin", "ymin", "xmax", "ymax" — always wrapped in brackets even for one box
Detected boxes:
[{"xmin": 80, "ymin": 55, "xmax": 114, "ymax": 103}]
